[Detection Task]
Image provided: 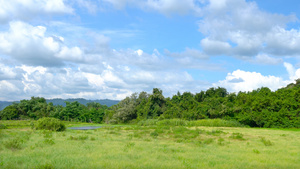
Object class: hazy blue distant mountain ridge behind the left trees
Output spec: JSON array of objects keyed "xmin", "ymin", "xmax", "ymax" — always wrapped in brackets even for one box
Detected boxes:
[{"xmin": 0, "ymin": 98, "xmax": 120, "ymax": 111}]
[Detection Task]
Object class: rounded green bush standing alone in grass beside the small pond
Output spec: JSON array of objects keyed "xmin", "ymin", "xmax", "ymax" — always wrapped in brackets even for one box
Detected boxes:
[{"xmin": 36, "ymin": 117, "xmax": 66, "ymax": 131}]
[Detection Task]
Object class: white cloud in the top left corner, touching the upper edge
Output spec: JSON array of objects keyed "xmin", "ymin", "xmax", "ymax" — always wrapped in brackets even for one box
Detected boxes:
[{"xmin": 0, "ymin": 0, "xmax": 74, "ymax": 23}]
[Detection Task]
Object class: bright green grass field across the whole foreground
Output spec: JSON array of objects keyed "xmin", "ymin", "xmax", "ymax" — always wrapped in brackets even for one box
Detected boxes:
[{"xmin": 0, "ymin": 121, "xmax": 300, "ymax": 169}]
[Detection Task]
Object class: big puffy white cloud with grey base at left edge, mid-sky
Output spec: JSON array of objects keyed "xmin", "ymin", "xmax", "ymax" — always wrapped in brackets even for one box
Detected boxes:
[{"xmin": 0, "ymin": 22, "xmax": 62, "ymax": 65}]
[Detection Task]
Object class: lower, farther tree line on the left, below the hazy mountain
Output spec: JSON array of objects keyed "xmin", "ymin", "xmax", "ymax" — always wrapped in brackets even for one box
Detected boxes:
[{"xmin": 0, "ymin": 97, "xmax": 108, "ymax": 123}]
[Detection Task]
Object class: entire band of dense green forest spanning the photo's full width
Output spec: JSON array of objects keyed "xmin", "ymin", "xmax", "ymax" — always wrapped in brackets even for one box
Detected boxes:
[{"xmin": 0, "ymin": 79, "xmax": 300, "ymax": 128}]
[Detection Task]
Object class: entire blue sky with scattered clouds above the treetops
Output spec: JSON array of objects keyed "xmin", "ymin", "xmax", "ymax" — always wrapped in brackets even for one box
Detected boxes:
[{"xmin": 0, "ymin": 0, "xmax": 300, "ymax": 101}]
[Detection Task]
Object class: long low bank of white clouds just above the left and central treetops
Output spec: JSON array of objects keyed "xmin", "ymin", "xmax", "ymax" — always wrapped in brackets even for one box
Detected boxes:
[{"xmin": 0, "ymin": 63, "xmax": 203, "ymax": 100}]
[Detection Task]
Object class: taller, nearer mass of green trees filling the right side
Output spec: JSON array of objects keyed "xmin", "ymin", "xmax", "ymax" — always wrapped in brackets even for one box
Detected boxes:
[{"xmin": 104, "ymin": 79, "xmax": 300, "ymax": 128}]
